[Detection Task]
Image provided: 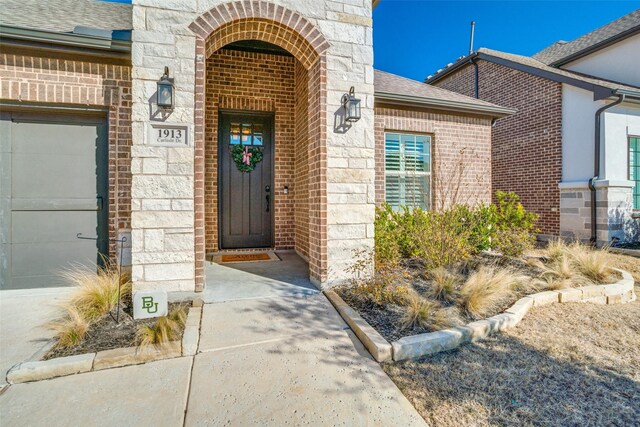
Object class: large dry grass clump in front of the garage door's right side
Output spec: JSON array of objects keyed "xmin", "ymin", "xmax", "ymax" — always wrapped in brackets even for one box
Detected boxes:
[{"xmin": 62, "ymin": 264, "xmax": 131, "ymax": 322}]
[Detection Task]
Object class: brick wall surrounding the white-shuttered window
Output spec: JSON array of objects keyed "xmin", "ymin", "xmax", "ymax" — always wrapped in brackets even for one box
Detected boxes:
[{"xmin": 375, "ymin": 105, "xmax": 491, "ymax": 209}]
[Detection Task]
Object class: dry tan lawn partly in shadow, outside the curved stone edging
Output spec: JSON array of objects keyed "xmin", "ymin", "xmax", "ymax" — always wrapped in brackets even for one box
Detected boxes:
[{"xmin": 383, "ymin": 301, "xmax": 640, "ymax": 427}]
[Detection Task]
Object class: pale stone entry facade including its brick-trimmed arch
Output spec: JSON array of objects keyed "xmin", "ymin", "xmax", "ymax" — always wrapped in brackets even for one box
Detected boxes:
[{"xmin": 132, "ymin": 0, "xmax": 375, "ymax": 291}]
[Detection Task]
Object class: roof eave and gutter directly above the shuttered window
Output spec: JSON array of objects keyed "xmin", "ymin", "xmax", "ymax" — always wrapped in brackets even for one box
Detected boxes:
[{"xmin": 374, "ymin": 91, "xmax": 516, "ymax": 118}]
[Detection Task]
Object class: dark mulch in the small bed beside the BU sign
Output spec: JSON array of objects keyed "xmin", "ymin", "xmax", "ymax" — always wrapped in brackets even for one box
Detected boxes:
[{"xmin": 43, "ymin": 303, "xmax": 184, "ymax": 360}]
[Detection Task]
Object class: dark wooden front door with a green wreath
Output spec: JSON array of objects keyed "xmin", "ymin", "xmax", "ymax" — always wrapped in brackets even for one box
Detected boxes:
[{"xmin": 218, "ymin": 112, "xmax": 274, "ymax": 249}]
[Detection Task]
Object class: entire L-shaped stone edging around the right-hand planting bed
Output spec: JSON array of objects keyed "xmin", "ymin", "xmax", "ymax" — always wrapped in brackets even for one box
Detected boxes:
[{"xmin": 325, "ymin": 269, "xmax": 636, "ymax": 362}]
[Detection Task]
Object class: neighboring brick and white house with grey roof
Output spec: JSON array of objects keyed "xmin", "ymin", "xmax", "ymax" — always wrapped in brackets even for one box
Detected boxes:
[{"xmin": 426, "ymin": 10, "xmax": 640, "ymax": 245}]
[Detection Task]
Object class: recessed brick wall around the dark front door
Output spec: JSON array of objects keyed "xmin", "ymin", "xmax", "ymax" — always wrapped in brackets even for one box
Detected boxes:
[{"xmin": 205, "ymin": 49, "xmax": 298, "ymax": 252}]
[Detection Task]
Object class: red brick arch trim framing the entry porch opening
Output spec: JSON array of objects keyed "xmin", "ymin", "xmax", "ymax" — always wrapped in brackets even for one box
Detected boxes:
[{"xmin": 189, "ymin": 0, "xmax": 329, "ymax": 291}]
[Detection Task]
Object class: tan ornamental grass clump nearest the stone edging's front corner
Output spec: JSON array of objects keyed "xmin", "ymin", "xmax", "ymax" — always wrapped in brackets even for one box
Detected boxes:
[{"xmin": 401, "ymin": 294, "xmax": 460, "ymax": 331}]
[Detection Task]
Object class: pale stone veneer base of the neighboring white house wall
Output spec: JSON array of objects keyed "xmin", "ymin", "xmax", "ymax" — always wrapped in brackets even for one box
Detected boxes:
[{"xmin": 560, "ymin": 184, "xmax": 640, "ymax": 246}]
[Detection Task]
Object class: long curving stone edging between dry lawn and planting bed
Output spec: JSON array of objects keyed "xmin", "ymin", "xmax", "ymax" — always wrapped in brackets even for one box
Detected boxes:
[{"xmin": 392, "ymin": 269, "xmax": 636, "ymax": 361}]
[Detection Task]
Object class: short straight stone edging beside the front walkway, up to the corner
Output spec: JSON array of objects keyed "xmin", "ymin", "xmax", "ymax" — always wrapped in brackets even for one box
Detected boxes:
[{"xmin": 324, "ymin": 289, "xmax": 393, "ymax": 362}]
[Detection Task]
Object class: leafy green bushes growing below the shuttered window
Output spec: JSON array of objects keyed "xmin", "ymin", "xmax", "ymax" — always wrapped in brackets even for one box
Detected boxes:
[{"xmin": 375, "ymin": 191, "xmax": 538, "ymax": 269}]
